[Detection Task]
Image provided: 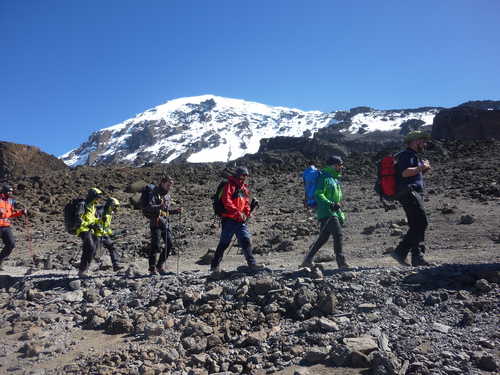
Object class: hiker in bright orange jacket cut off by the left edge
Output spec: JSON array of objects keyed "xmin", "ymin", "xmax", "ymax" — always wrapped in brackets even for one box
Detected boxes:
[{"xmin": 0, "ymin": 185, "xmax": 27, "ymax": 270}]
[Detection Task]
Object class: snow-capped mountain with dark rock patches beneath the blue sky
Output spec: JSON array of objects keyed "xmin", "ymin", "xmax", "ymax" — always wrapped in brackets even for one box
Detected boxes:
[{"xmin": 60, "ymin": 95, "xmax": 438, "ymax": 166}]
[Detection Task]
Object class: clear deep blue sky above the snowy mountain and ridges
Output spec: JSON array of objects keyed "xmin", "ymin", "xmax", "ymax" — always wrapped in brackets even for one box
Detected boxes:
[{"xmin": 0, "ymin": 0, "xmax": 500, "ymax": 156}]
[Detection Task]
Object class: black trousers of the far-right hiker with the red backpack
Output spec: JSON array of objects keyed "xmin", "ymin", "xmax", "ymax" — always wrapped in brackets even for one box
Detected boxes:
[{"xmin": 396, "ymin": 191, "xmax": 428, "ymax": 258}]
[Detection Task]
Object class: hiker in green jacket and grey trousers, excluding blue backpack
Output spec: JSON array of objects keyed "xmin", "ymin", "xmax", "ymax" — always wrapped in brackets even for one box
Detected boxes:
[{"xmin": 301, "ymin": 156, "xmax": 349, "ymax": 269}]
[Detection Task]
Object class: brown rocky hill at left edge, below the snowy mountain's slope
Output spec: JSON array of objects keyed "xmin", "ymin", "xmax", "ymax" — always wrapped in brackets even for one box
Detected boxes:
[{"xmin": 0, "ymin": 142, "xmax": 67, "ymax": 181}]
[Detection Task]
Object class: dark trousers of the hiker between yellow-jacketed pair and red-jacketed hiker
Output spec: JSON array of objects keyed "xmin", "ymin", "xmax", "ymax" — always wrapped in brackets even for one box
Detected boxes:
[{"xmin": 149, "ymin": 218, "xmax": 173, "ymax": 271}]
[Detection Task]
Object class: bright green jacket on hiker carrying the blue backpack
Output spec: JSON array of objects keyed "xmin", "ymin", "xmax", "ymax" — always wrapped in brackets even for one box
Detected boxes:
[{"xmin": 314, "ymin": 166, "xmax": 345, "ymax": 223}]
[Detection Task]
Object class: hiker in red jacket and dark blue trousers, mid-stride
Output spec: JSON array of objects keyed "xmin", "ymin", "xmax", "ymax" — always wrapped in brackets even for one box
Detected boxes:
[{"xmin": 210, "ymin": 167, "xmax": 263, "ymax": 276}]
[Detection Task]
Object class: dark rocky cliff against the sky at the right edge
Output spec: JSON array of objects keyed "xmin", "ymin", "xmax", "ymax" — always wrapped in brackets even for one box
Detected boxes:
[{"xmin": 432, "ymin": 101, "xmax": 500, "ymax": 140}]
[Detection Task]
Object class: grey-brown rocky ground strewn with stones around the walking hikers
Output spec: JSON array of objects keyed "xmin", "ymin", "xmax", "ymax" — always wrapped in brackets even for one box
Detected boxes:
[{"xmin": 0, "ymin": 142, "xmax": 500, "ymax": 374}]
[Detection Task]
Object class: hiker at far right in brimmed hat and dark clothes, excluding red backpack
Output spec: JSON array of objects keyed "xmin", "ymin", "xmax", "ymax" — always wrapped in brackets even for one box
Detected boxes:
[{"xmin": 389, "ymin": 131, "xmax": 431, "ymax": 267}]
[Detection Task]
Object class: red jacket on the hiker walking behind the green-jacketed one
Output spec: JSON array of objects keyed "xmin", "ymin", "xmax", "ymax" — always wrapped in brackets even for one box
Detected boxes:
[{"xmin": 221, "ymin": 176, "xmax": 250, "ymax": 222}]
